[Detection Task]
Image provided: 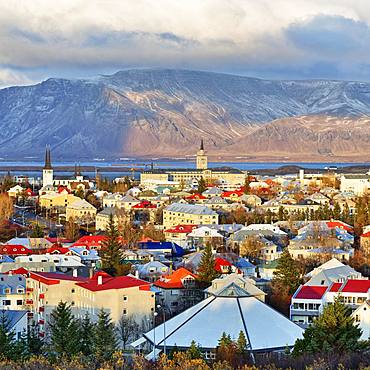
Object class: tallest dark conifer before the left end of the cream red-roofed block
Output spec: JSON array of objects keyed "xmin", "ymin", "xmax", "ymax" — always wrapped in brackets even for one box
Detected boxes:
[{"xmin": 49, "ymin": 302, "xmax": 80, "ymax": 357}]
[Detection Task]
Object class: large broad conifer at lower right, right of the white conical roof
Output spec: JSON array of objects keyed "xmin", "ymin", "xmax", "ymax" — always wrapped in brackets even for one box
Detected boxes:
[{"xmin": 293, "ymin": 297, "xmax": 361, "ymax": 356}]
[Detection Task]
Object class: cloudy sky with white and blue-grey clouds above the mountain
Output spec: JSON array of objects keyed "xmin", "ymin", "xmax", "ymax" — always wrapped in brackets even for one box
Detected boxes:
[{"xmin": 0, "ymin": 0, "xmax": 370, "ymax": 87}]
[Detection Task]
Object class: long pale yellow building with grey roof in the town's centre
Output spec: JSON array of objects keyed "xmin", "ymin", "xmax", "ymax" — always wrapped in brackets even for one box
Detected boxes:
[{"xmin": 163, "ymin": 203, "xmax": 218, "ymax": 229}]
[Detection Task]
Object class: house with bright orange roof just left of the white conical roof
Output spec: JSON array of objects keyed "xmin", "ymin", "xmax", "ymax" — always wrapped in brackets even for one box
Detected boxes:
[{"xmin": 154, "ymin": 267, "xmax": 203, "ymax": 314}]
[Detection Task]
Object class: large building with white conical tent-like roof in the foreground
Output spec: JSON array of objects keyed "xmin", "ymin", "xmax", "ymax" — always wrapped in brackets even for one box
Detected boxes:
[{"xmin": 131, "ymin": 282, "xmax": 303, "ymax": 359}]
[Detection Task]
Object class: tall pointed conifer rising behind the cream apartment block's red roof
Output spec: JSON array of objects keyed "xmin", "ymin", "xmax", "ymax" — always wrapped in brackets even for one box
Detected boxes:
[{"xmin": 100, "ymin": 214, "xmax": 122, "ymax": 275}]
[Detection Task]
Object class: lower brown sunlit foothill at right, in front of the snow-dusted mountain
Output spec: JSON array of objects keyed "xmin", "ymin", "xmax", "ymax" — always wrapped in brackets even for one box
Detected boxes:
[{"xmin": 223, "ymin": 116, "xmax": 370, "ymax": 161}]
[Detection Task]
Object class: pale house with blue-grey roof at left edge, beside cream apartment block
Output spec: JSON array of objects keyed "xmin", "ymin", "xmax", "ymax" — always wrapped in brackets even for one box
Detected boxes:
[{"xmin": 0, "ymin": 273, "xmax": 26, "ymax": 311}]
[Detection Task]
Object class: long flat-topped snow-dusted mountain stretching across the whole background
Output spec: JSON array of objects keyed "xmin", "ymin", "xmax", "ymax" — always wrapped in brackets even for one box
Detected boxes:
[{"xmin": 0, "ymin": 69, "xmax": 370, "ymax": 159}]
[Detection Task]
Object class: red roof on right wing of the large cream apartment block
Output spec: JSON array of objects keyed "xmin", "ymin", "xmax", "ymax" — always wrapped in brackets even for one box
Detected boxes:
[{"xmin": 76, "ymin": 271, "xmax": 150, "ymax": 292}]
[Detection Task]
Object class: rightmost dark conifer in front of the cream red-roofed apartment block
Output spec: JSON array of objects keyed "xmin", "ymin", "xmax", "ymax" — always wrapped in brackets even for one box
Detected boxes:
[{"xmin": 94, "ymin": 309, "xmax": 117, "ymax": 361}]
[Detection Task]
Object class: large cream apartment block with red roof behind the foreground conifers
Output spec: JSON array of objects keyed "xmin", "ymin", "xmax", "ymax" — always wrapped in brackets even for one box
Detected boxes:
[{"xmin": 26, "ymin": 271, "xmax": 155, "ymax": 331}]
